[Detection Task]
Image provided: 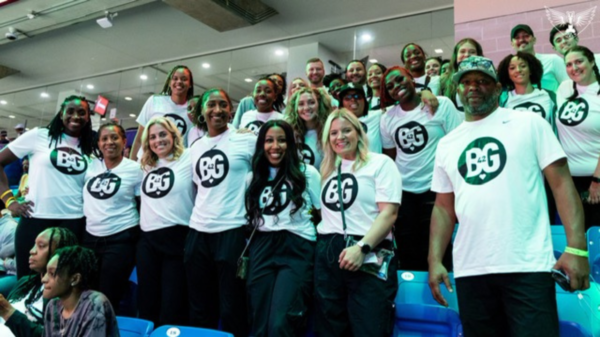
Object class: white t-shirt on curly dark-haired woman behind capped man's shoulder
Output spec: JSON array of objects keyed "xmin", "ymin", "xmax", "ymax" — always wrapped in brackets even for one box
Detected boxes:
[{"xmin": 505, "ymin": 88, "xmax": 555, "ymax": 125}]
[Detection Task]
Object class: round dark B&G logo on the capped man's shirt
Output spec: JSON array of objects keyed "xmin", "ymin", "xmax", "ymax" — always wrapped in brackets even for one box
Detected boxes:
[{"xmin": 458, "ymin": 137, "xmax": 506, "ymax": 185}]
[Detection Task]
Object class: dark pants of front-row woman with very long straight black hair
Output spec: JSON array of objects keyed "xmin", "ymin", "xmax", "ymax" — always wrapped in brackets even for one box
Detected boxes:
[{"xmin": 247, "ymin": 231, "xmax": 316, "ymax": 337}]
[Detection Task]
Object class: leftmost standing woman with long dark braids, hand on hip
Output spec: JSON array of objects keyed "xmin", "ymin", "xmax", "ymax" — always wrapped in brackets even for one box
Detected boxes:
[{"xmin": 0, "ymin": 96, "xmax": 93, "ymax": 278}]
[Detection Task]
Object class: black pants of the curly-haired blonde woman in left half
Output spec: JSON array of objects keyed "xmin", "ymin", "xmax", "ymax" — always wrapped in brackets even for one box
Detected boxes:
[{"xmin": 136, "ymin": 226, "xmax": 189, "ymax": 326}]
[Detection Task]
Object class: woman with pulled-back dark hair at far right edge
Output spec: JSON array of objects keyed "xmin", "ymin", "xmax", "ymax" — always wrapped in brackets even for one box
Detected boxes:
[{"xmin": 556, "ymin": 46, "xmax": 600, "ymax": 230}]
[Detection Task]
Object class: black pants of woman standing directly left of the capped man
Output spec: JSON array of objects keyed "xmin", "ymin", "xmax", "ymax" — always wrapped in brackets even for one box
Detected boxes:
[{"xmin": 394, "ymin": 191, "xmax": 452, "ymax": 271}]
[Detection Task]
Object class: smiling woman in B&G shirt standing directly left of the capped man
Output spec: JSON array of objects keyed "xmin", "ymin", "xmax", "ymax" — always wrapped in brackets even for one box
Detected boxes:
[{"xmin": 381, "ymin": 66, "xmax": 462, "ymax": 271}]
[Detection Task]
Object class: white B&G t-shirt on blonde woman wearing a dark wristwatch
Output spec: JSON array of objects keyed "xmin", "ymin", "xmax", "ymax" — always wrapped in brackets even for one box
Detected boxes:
[{"xmin": 317, "ymin": 153, "xmax": 402, "ymax": 240}]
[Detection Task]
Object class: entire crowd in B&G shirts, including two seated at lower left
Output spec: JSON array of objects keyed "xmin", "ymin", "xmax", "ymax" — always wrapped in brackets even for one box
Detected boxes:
[{"xmin": 0, "ymin": 21, "xmax": 600, "ymax": 337}]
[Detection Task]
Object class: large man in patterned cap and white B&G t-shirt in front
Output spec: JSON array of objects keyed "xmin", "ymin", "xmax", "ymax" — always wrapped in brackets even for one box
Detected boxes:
[{"xmin": 429, "ymin": 56, "xmax": 590, "ymax": 337}]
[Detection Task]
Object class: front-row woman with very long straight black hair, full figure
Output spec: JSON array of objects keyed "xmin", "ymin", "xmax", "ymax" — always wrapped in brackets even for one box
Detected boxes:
[{"xmin": 246, "ymin": 120, "xmax": 321, "ymax": 336}]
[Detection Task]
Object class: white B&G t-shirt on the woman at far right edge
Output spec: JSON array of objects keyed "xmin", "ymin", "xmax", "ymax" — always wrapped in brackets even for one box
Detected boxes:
[{"xmin": 556, "ymin": 80, "xmax": 600, "ymax": 177}]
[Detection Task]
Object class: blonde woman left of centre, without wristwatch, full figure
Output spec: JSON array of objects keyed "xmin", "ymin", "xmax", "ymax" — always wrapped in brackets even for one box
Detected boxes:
[{"xmin": 137, "ymin": 117, "xmax": 194, "ymax": 326}]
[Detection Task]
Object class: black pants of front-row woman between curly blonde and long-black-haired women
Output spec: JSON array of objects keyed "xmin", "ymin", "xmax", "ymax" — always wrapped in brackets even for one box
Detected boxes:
[{"xmin": 184, "ymin": 227, "xmax": 249, "ymax": 337}]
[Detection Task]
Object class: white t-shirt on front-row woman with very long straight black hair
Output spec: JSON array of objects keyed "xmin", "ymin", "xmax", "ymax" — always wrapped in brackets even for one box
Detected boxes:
[{"xmin": 248, "ymin": 165, "xmax": 321, "ymax": 241}]
